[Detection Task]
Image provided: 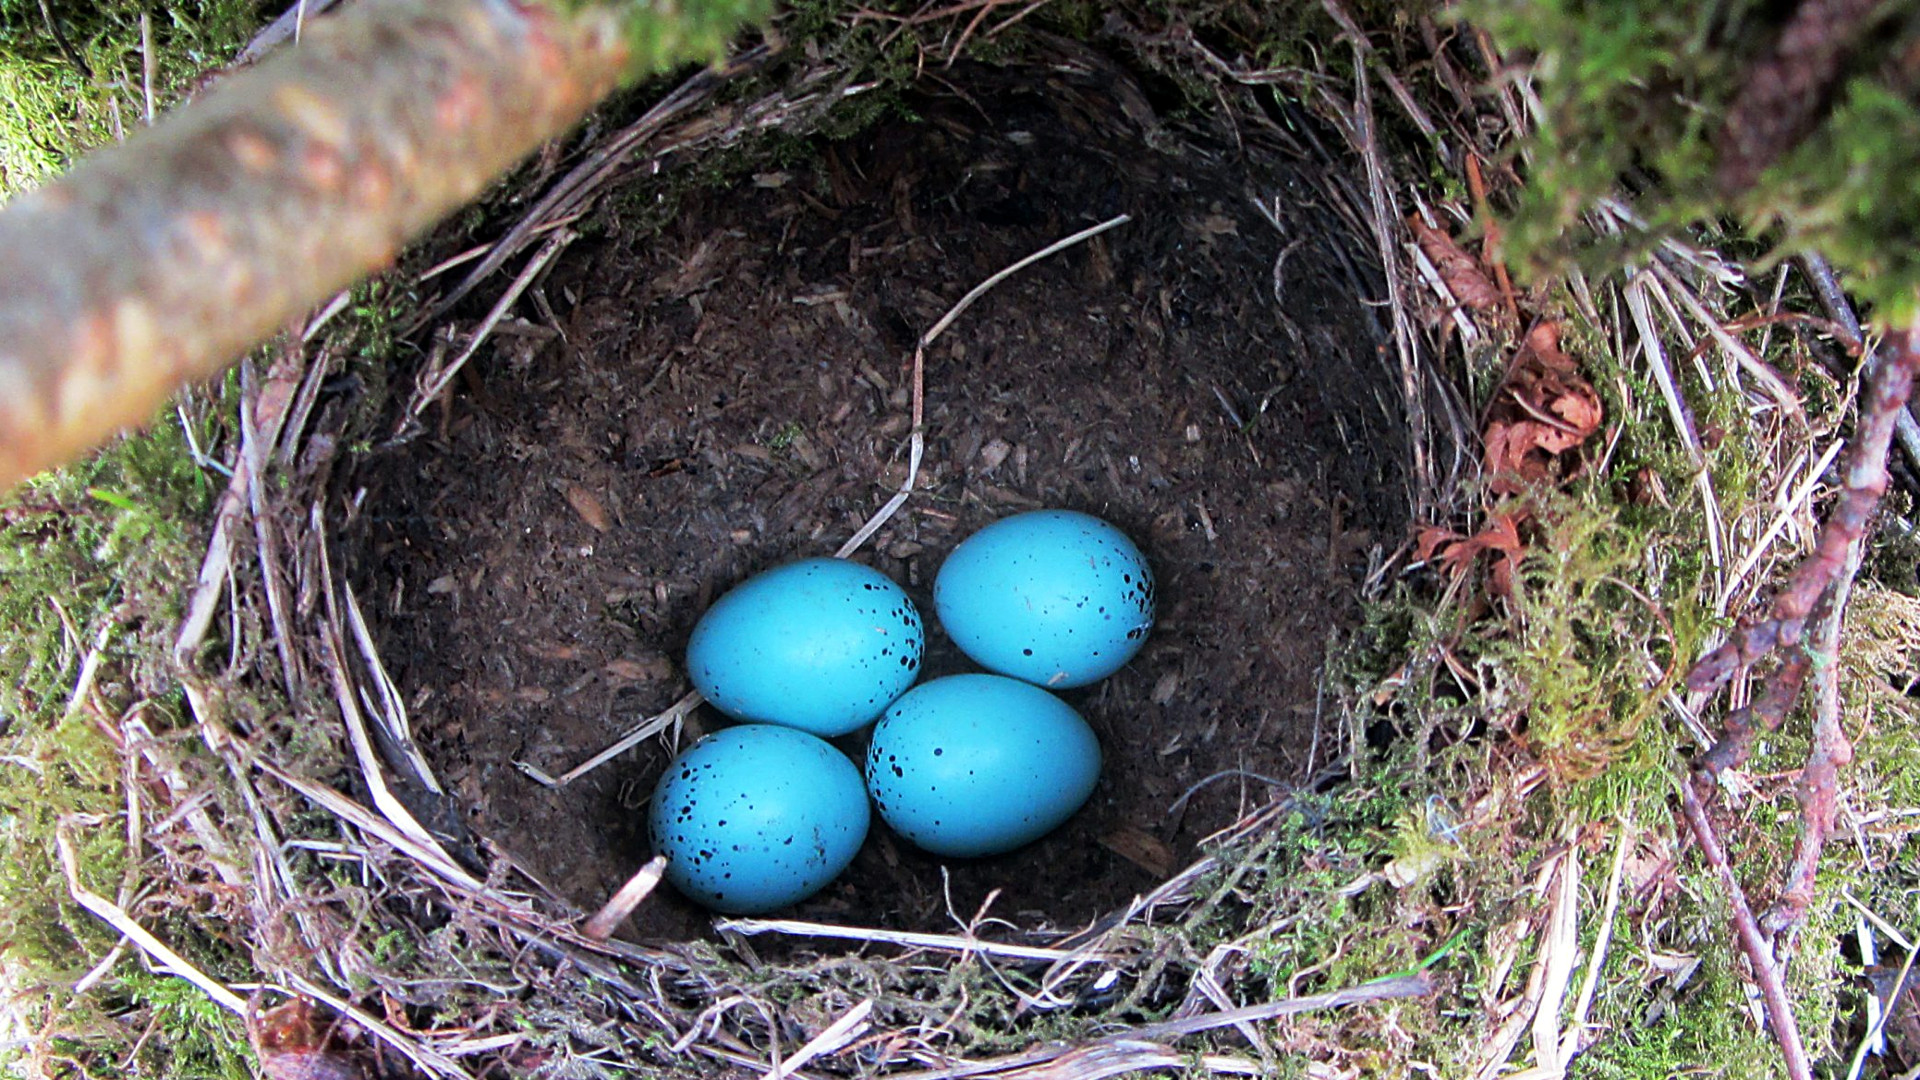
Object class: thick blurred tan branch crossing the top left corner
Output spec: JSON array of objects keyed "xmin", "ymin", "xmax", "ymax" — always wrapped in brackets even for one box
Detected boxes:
[{"xmin": 0, "ymin": 0, "xmax": 630, "ymax": 490}]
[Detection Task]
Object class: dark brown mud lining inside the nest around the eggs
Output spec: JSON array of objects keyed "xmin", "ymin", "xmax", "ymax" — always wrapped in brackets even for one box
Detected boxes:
[{"xmin": 355, "ymin": 58, "xmax": 1405, "ymax": 940}]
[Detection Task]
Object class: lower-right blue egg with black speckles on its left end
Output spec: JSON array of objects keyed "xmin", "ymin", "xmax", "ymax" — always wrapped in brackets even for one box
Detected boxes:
[{"xmin": 866, "ymin": 675, "xmax": 1100, "ymax": 859}]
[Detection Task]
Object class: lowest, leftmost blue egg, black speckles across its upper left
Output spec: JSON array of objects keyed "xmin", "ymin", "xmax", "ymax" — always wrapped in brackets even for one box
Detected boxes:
[{"xmin": 647, "ymin": 724, "xmax": 872, "ymax": 915}]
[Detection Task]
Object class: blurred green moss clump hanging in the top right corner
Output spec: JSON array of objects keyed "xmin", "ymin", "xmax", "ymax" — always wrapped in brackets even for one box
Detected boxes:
[{"xmin": 1463, "ymin": 0, "xmax": 1920, "ymax": 321}]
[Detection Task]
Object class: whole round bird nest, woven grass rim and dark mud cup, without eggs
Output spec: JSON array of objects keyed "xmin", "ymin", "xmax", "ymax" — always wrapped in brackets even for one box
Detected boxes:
[{"xmin": 153, "ymin": 4, "xmax": 1465, "ymax": 1078}]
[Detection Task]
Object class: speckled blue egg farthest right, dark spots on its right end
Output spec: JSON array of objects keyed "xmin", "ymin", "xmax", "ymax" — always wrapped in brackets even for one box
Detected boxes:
[{"xmin": 933, "ymin": 509, "xmax": 1154, "ymax": 688}]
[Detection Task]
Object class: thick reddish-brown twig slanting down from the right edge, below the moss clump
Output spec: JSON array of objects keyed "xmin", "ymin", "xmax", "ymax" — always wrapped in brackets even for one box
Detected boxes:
[{"xmin": 1688, "ymin": 331, "xmax": 1920, "ymax": 694}]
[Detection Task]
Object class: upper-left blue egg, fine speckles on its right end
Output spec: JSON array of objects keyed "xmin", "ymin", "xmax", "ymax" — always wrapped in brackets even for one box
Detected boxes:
[{"xmin": 687, "ymin": 559, "xmax": 925, "ymax": 738}]
